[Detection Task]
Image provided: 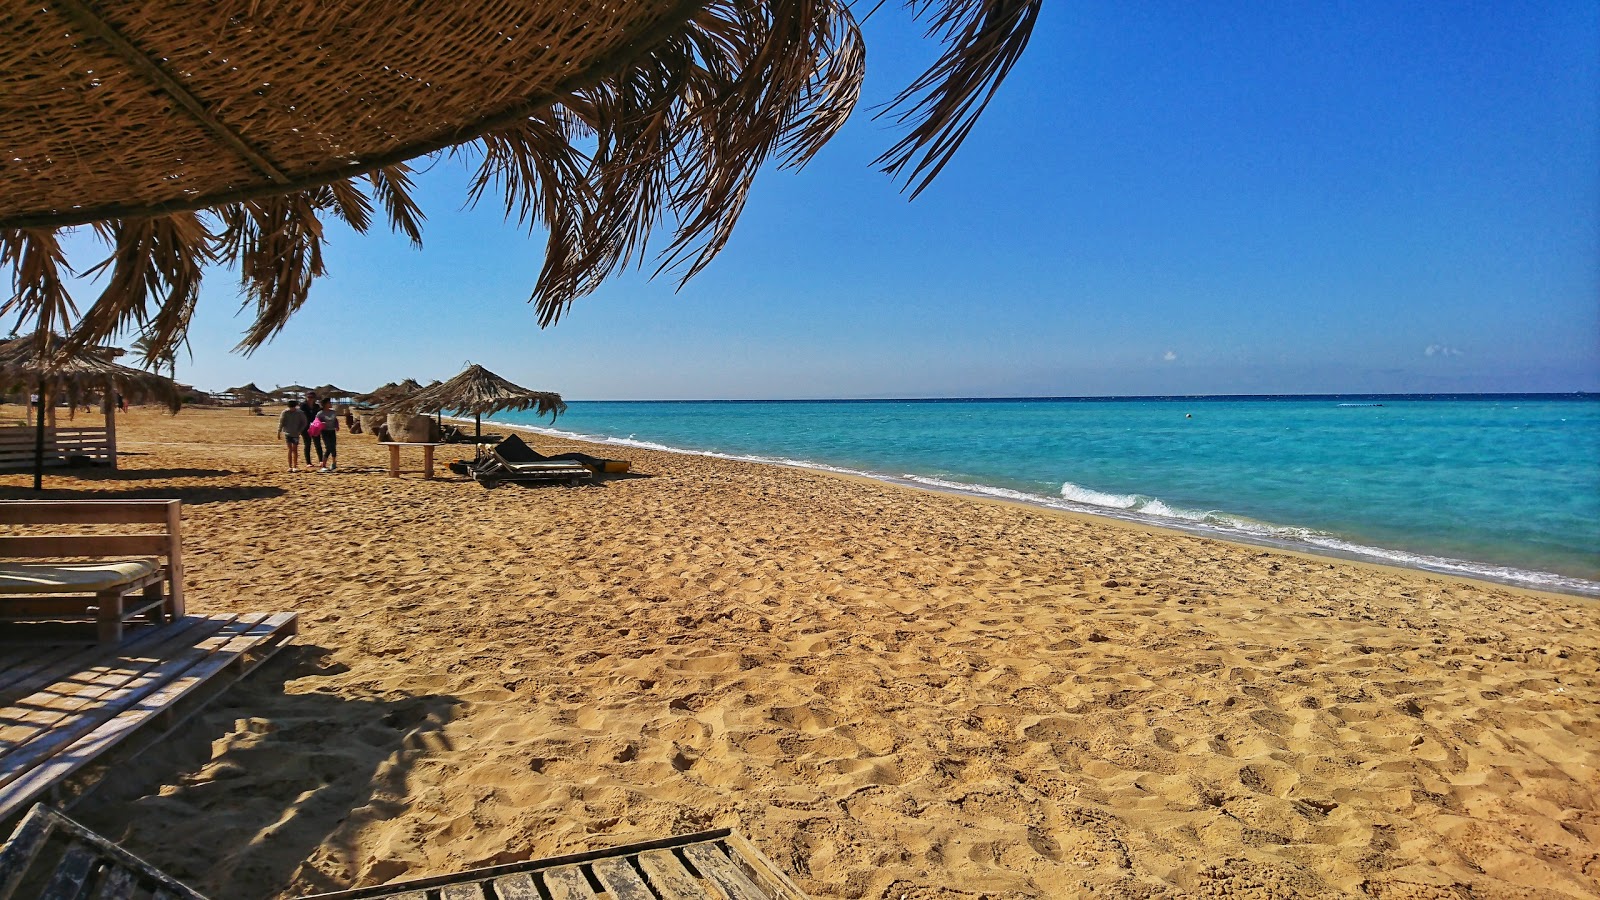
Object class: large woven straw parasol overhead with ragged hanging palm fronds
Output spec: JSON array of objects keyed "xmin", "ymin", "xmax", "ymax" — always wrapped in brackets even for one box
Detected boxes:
[{"xmin": 0, "ymin": 0, "xmax": 1043, "ymax": 356}]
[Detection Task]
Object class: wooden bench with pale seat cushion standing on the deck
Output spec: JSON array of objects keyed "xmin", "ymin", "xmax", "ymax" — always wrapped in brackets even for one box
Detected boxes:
[{"xmin": 0, "ymin": 500, "xmax": 184, "ymax": 644}]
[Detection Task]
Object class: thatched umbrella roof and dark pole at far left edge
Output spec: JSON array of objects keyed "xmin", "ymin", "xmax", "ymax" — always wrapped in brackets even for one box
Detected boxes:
[{"xmin": 0, "ymin": 335, "xmax": 182, "ymax": 490}]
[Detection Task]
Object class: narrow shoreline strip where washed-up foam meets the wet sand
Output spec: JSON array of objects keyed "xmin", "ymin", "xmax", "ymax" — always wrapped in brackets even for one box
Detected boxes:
[{"xmin": 473, "ymin": 416, "xmax": 1600, "ymax": 601}]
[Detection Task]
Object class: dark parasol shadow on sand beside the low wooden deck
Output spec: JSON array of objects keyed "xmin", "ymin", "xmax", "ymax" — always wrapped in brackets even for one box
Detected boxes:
[{"xmin": 69, "ymin": 645, "xmax": 459, "ymax": 900}]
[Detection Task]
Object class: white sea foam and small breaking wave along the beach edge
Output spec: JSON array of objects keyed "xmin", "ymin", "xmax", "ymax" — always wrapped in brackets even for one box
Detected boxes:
[{"xmin": 483, "ymin": 420, "xmax": 1600, "ymax": 597}]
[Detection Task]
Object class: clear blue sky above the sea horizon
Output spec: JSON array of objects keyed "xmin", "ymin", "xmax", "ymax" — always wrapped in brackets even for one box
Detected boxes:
[{"xmin": 50, "ymin": 0, "xmax": 1600, "ymax": 400}]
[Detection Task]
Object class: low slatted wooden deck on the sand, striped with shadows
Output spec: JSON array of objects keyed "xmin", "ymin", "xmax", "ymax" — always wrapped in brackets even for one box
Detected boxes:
[{"xmin": 0, "ymin": 613, "xmax": 296, "ymax": 823}]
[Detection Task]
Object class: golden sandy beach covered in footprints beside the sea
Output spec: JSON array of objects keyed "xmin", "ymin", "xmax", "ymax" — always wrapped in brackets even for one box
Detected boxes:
[{"xmin": 0, "ymin": 407, "xmax": 1600, "ymax": 900}]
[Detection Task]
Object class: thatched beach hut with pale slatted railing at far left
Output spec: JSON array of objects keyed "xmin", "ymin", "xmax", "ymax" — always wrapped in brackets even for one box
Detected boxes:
[{"xmin": 0, "ymin": 335, "xmax": 182, "ymax": 490}]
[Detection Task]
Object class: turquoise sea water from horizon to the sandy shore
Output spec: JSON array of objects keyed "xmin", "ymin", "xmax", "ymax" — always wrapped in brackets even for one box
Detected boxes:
[{"xmin": 499, "ymin": 394, "xmax": 1600, "ymax": 596}]
